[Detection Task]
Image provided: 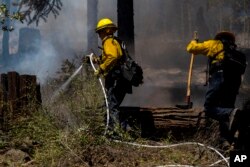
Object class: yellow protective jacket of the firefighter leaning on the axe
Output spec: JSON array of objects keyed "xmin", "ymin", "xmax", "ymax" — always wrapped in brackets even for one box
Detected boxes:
[{"xmin": 187, "ymin": 40, "xmax": 224, "ymax": 64}]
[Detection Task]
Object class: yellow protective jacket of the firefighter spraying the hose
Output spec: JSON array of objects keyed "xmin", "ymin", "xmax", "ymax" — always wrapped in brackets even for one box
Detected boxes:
[{"xmin": 100, "ymin": 36, "xmax": 122, "ymax": 76}]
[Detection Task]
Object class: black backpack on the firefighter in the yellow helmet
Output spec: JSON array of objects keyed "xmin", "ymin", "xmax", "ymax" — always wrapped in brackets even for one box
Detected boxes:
[{"xmin": 117, "ymin": 39, "xmax": 143, "ymax": 87}]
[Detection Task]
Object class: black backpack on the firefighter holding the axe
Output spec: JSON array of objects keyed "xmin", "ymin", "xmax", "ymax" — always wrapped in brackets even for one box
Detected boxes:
[{"xmin": 223, "ymin": 43, "xmax": 247, "ymax": 75}]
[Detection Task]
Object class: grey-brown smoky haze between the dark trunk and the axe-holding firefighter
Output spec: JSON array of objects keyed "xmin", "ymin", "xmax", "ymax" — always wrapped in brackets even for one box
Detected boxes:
[{"xmin": 123, "ymin": 0, "xmax": 249, "ymax": 107}]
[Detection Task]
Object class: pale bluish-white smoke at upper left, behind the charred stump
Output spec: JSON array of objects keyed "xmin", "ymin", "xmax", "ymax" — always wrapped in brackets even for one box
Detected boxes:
[{"xmin": 1, "ymin": 0, "xmax": 87, "ymax": 84}]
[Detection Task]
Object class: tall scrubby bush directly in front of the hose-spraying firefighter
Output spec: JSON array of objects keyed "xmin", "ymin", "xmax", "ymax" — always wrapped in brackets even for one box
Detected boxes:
[{"xmin": 52, "ymin": 66, "xmax": 105, "ymax": 132}]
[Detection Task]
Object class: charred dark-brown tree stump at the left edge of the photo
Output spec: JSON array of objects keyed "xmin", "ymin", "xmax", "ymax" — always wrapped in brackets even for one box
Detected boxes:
[{"xmin": 0, "ymin": 72, "xmax": 42, "ymax": 131}]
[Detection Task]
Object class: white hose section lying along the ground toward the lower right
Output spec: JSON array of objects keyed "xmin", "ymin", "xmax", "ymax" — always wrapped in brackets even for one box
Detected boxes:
[{"xmin": 113, "ymin": 140, "xmax": 229, "ymax": 166}]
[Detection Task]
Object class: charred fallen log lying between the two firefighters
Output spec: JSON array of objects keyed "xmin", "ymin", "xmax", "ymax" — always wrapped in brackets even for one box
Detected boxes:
[{"xmin": 120, "ymin": 107, "xmax": 206, "ymax": 139}]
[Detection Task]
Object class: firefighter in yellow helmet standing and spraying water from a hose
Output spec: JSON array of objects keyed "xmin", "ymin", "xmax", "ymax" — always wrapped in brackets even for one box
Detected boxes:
[{"xmin": 94, "ymin": 18, "xmax": 132, "ymax": 137}]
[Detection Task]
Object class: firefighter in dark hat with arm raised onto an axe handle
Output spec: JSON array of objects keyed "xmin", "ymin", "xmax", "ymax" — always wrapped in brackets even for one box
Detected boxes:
[{"xmin": 187, "ymin": 31, "xmax": 246, "ymax": 150}]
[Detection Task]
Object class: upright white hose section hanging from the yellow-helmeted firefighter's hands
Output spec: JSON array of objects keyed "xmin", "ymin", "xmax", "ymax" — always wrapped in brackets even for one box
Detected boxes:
[{"xmin": 87, "ymin": 53, "xmax": 109, "ymax": 135}]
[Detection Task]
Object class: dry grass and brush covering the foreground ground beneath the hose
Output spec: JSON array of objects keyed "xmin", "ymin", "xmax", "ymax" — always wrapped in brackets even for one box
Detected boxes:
[{"xmin": 0, "ymin": 61, "xmax": 230, "ymax": 167}]
